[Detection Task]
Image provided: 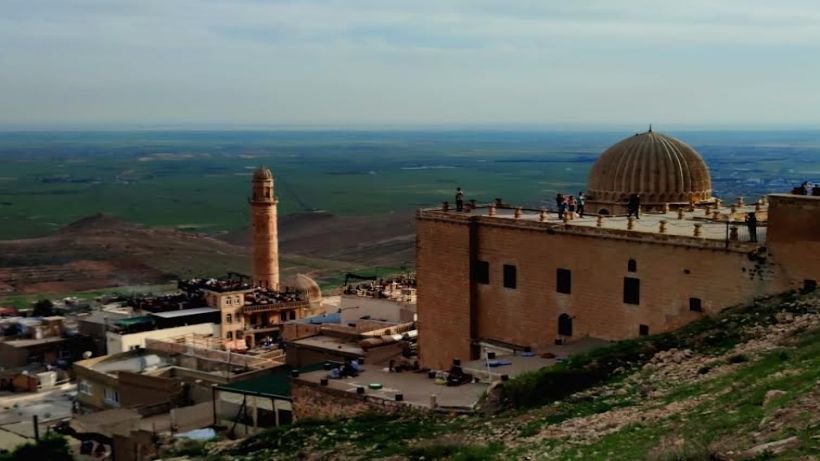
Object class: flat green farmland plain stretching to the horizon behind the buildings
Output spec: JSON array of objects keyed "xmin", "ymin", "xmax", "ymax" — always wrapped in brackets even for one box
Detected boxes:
[{"xmin": 0, "ymin": 127, "xmax": 820, "ymax": 240}]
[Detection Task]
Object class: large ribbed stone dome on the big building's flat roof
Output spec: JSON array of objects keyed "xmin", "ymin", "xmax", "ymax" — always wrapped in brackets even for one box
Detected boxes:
[{"xmin": 587, "ymin": 129, "xmax": 712, "ymax": 204}]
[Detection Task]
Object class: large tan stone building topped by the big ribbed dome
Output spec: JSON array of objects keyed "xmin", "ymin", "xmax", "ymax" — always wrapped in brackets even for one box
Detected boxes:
[{"xmin": 416, "ymin": 128, "xmax": 820, "ymax": 369}]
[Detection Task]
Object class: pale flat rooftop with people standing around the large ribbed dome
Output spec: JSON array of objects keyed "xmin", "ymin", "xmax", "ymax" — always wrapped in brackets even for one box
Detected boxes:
[{"xmin": 417, "ymin": 204, "xmax": 768, "ymax": 251}]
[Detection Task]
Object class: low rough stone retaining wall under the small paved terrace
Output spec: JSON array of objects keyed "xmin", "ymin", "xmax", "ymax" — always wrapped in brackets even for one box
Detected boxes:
[{"xmin": 291, "ymin": 379, "xmax": 402, "ymax": 419}]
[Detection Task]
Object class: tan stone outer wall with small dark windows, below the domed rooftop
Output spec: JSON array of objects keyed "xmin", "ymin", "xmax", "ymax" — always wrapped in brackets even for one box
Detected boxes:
[{"xmin": 417, "ymin": 212, "xmax": 789, "ymax": 369}]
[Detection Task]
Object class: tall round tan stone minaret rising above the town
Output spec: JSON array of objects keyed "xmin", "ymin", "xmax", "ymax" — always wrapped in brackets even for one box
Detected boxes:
[{"xmin": 248, "ymin": 167, "xmax": 279, "ymax": 289}]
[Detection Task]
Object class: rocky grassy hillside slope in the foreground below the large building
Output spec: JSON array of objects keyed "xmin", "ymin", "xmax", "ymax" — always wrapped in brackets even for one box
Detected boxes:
[{"xmin": 181, "ymin": 294, "xmax": 820, "ymax": 461}]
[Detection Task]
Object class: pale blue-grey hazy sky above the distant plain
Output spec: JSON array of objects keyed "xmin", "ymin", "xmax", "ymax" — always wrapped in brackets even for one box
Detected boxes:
[{"xmin": 0, "ymin": 0, "xmax": 820, "ymax": 127}]
